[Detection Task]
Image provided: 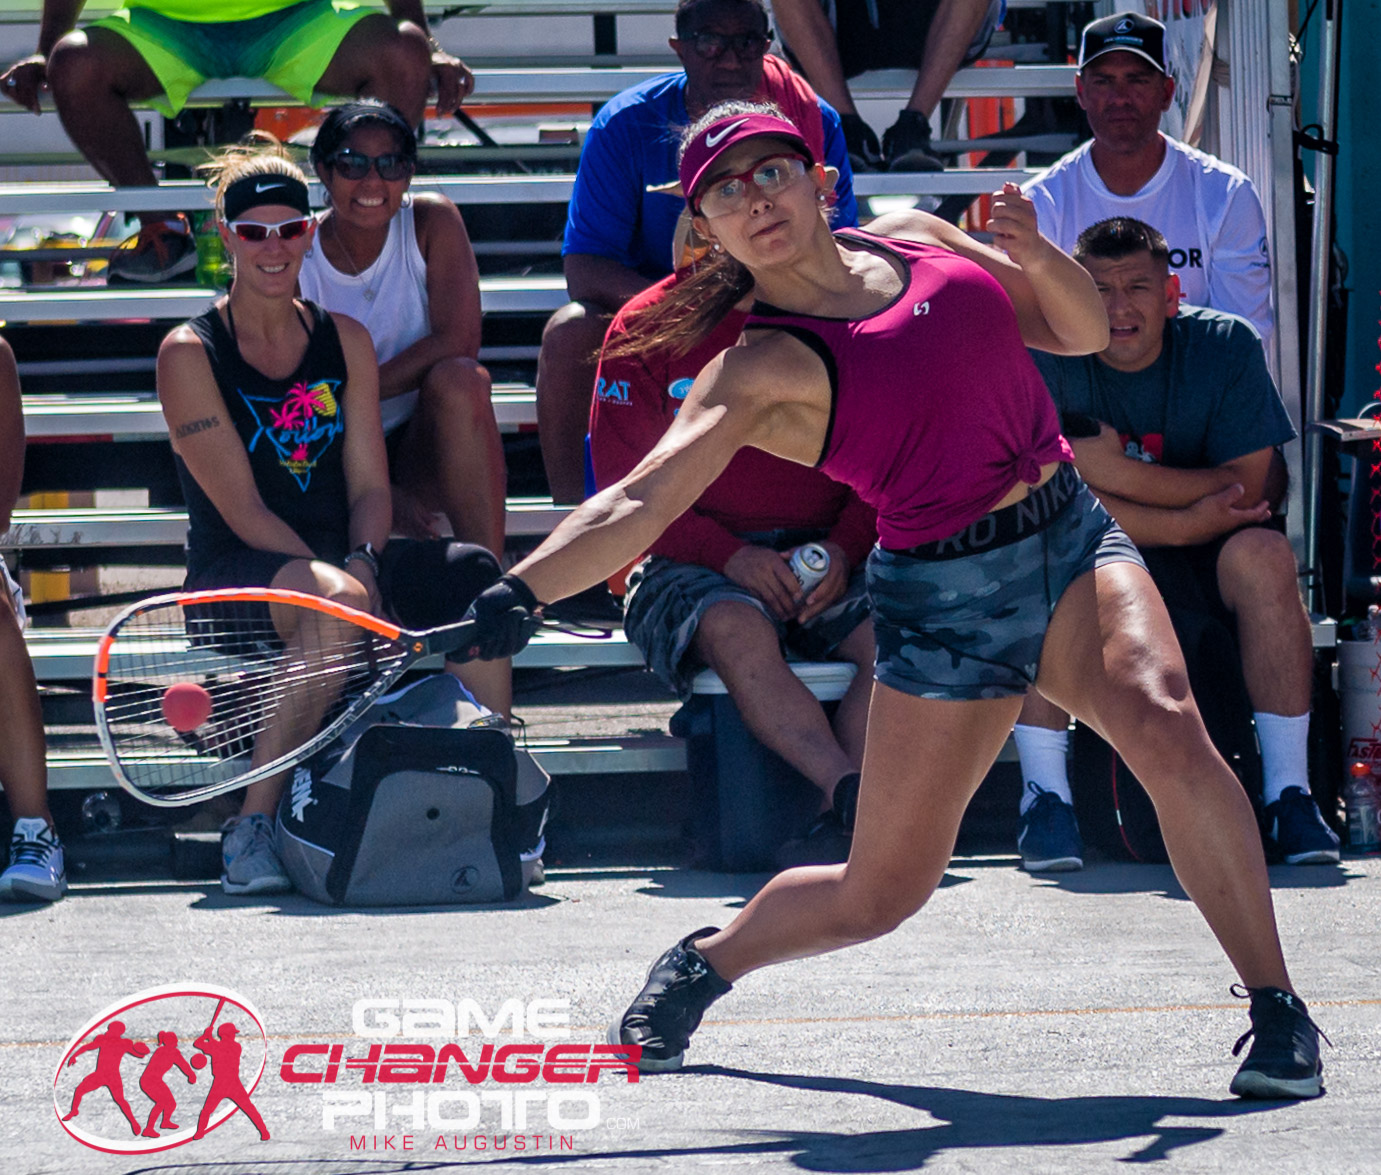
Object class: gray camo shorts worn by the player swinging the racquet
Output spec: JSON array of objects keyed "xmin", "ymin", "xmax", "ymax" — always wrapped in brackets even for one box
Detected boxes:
[{"xmin": 867, "ymin": 467, "xmax": 1145, "ymax": 701}]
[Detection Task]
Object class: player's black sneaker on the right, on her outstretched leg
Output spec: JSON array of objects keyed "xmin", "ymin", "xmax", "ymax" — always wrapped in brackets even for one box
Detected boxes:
[{"xmin": 1229, "ymin": 983, "xmax": 1331, "ymax": 1098}]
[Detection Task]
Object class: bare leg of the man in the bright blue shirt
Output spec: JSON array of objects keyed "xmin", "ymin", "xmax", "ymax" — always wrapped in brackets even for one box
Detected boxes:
[{"xmin": 537, "ymin": 302, "xmax": 610, "ymax": 505}]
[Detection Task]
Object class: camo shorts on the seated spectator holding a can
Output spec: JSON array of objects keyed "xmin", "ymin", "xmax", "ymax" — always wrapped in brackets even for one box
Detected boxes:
[{"xmin": 623, "ymin": 532, "xmax": 869, "ymax": 701}]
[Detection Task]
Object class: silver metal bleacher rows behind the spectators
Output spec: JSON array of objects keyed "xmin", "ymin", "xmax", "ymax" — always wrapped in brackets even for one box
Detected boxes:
[{"xmin": 0, "ymin": 0, "xmax": 1073, "ymax": 788}]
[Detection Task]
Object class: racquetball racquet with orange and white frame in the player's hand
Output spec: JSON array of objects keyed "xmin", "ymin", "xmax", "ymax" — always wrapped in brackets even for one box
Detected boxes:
[{"xmin": 91, "ymin": 588, "xmax": 508, "ymax": 808}]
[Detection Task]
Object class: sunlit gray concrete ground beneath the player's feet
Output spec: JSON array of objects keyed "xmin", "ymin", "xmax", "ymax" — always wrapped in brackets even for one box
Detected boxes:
[{"xmin": 0, "ymin": 857, "xmax": 1381, "ymax": 1175}]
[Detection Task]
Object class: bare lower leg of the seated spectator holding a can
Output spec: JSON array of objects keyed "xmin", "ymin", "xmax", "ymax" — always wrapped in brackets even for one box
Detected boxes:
[{"xmin": 695, "ymin": 601, "xmax": 855, "ymax": 808}]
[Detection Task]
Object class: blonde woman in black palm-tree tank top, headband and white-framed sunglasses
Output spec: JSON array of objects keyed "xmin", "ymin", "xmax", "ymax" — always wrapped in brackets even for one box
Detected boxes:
[{"xmin": 157, "ymin": 139, "xmax": 499, "ymax": 893}]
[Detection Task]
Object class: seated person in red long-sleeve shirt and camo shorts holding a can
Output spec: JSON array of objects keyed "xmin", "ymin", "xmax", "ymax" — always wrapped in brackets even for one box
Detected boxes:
[{"xmin": 590, "ymin": 276, "xmax": 877, "ymax": 867}]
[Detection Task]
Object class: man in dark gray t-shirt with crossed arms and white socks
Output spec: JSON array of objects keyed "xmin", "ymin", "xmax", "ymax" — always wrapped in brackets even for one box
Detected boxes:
[{"xmin": 1016, "ymin": 217, "xmax": 1338, "ymax": 873}]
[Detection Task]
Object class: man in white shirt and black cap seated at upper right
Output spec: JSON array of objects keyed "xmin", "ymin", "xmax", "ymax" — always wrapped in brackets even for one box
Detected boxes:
[{"xmin": 1026, "ymin": 12, "xmax": 1275, "ymax": 356}]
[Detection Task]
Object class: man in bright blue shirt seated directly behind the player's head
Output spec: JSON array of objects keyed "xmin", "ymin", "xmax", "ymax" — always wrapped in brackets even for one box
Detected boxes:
[{"xmin": 537, "ymin": 0, "xmax": 858, "ymax": 503}]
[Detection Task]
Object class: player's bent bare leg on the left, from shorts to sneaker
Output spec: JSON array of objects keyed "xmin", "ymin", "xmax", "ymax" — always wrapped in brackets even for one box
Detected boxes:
[{"xmin": 697, "ymin": 683, "xmax": 1021, "ymax": 982}]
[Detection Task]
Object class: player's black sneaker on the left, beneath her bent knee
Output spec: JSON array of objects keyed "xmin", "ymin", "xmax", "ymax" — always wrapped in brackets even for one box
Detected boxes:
[{"xmin": 609, "ymin": 926, "xmax": 733, "ymax": 1073}]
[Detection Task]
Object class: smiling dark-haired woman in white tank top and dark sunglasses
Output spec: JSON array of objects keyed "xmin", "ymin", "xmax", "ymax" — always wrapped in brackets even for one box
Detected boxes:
[{"xmin": 298, "ymin": 98, "xmax": 512, "ymax": 714}]
